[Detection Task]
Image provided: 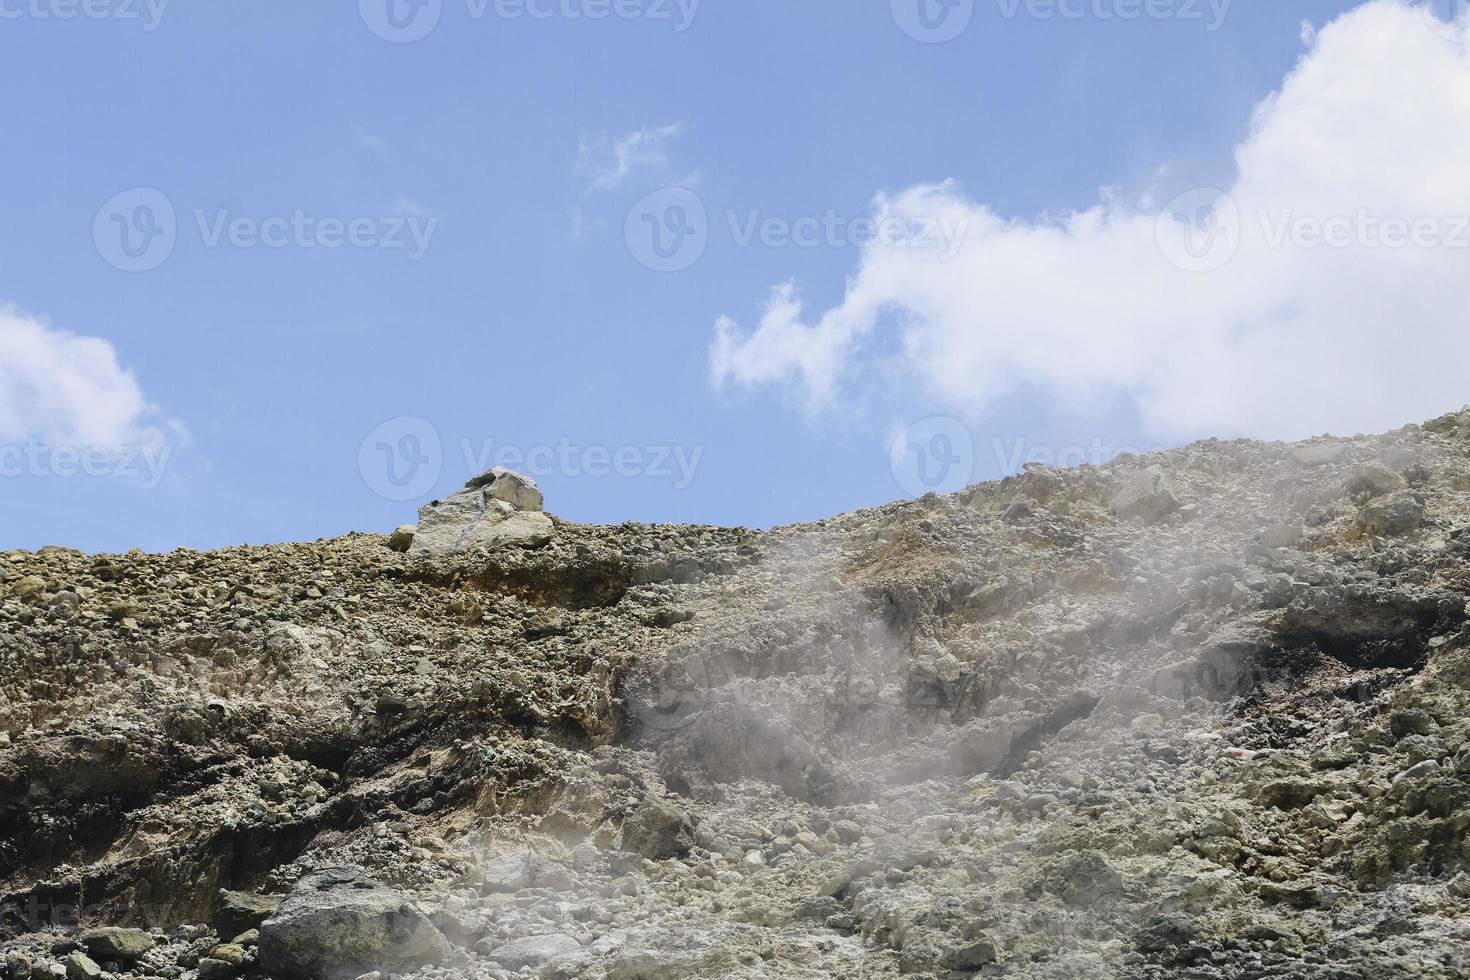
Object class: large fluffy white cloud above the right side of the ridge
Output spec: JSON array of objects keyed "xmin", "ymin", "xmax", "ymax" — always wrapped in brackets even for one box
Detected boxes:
[{"xmin": 711, "ymin": 0, "xmax": 1470, "ymax": 438}]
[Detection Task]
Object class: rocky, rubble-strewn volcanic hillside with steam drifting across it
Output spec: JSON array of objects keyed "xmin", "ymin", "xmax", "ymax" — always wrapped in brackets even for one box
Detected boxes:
[{"xmin": 0, "ymin": 410, "xmax": 1470, "ymax": 980}]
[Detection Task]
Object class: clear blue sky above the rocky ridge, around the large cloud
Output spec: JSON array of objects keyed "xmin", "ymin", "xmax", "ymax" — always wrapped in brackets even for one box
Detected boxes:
[{"xmin": 0, "ymin": 0, "xmax": 1467, "ymax": 551}]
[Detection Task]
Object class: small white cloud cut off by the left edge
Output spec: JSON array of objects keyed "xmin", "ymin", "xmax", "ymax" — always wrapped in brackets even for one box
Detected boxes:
[{"xmin": 0, "ymin": 306, "xmax": 182, "ymax": 448}]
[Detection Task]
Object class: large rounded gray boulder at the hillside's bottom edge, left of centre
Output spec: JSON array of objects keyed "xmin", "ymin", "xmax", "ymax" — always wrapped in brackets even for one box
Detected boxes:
[{"xmin": 260, "ymin": 867, "xmax": 450, "ymax": 980}]
